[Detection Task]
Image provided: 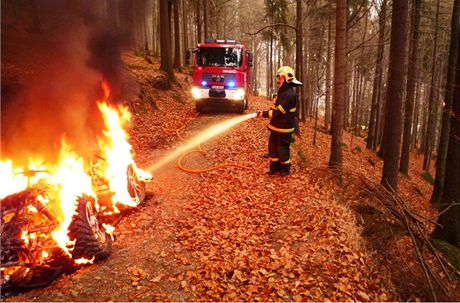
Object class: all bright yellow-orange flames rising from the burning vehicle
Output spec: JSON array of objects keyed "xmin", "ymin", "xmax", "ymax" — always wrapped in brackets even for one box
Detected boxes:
[{"xmin": 0, "ymin": 82, "xmax": 152, "ymax": 273}]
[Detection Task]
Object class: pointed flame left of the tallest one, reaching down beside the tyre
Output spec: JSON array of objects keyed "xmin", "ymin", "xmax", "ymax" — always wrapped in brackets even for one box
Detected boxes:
[{"xmin": 50, "ymin": 140, "xmax": 95, "ymax": 255}]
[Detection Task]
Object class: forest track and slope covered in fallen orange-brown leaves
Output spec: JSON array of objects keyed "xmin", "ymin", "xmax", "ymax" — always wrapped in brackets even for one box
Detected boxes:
[{"xmin": 7, "ymin": 54, "xmax": 455, "ymax": 301}]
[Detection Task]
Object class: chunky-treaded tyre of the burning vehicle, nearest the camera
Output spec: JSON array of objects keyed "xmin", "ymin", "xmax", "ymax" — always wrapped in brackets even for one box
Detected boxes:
[{"xmin": 69, "ymin": 196, "xmax": 112, "ymax": 261}]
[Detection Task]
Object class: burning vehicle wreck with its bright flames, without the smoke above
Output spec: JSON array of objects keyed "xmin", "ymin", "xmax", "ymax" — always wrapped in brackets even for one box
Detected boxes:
[{"xmin": 0, "ymin": 84, "xmax": 152, "ymax": 295}]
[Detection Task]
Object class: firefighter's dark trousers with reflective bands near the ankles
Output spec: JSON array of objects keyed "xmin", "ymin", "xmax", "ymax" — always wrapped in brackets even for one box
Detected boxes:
[{"xmin": 268, "ymin": 132, "xmax": 292, "ymax": 173}]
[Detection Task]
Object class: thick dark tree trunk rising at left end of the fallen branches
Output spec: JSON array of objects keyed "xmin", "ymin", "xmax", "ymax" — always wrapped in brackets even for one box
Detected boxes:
[{"xmin": 381, "ymin": 0, "xmax": 408, "ymax": 191}]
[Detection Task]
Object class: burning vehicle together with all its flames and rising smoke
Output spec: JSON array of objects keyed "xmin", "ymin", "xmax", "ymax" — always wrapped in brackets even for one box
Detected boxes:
[{"xmin": 0, "ymin": 0, "xmax": 151, "ymax": 295}]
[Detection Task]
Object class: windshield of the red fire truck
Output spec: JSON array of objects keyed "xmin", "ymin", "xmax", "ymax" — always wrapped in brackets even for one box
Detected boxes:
[{"xmin": 197, "ymin": 47, "xmax": 243, "ymax": 67}]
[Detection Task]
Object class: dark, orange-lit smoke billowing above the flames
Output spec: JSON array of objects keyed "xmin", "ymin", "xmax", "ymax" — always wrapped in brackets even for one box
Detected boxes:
[{"xmin": 0, "ymin": 0, "xmax": 131, "ymax": 164}]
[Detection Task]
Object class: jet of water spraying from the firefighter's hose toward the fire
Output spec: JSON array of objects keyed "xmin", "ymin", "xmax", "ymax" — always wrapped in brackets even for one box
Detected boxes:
[{"xmin": 147, "ymin": 113, "xmax": 257, "ymax": 173}]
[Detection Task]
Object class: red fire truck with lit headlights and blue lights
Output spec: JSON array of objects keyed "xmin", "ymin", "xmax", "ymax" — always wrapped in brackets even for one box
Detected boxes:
[{"xmin": 186, "ymin": 39, "xmax": 253, "ymax": 113}]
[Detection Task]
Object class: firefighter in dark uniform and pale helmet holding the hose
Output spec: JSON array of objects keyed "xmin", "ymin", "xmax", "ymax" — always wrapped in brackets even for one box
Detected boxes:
[{"xmin": 257, "ymin": 66, "xmax": 302, "ymax": 177}]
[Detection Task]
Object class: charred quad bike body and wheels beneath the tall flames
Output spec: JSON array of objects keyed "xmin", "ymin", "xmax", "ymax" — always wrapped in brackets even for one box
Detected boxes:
[{"xmin": 0, "ymin": 156, "xmax": 150, "ymax": 296}]
